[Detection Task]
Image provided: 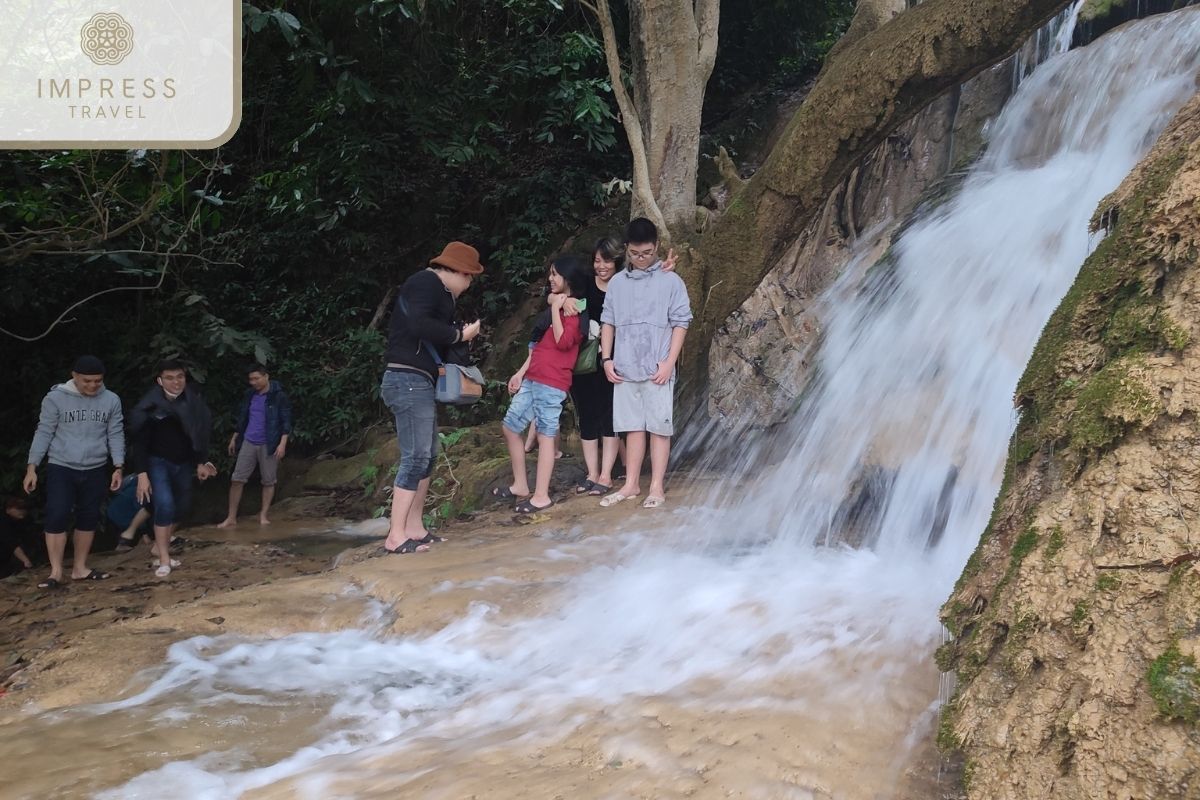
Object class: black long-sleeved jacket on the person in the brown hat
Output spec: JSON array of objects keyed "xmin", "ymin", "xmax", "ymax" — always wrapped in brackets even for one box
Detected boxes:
[{"xmin": 388, "ymin": 270, "xmax": 462, "ymax": 375}]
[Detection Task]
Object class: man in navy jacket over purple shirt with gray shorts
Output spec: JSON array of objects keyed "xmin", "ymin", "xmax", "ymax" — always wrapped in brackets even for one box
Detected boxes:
[{"xmin": 217, "ymin": 363, "xmax": 292, "ymax": 528}]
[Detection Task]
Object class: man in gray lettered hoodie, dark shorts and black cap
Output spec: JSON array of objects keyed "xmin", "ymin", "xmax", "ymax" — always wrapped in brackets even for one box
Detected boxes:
[{"xmin": 24, "ymin": 355, "xmax": 125, "ymax": 589}]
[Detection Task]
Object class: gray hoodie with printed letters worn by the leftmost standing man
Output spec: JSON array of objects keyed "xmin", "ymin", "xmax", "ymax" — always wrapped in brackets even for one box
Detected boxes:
[{"xmin": 26, "ymin": 380, "xmax": 125, "ymax": 469}]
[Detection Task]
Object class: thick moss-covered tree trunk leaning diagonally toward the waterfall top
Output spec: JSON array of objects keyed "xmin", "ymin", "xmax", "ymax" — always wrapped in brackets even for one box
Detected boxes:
[{"xmin": 682, "ymin": 0, "xmax": 1068, "ymax": 398}]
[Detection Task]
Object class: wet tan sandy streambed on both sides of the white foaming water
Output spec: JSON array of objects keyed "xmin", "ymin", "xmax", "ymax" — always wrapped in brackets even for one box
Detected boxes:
[{"xmin": 0, "ymin": 489, "xmax": 955, "ymax": 800}]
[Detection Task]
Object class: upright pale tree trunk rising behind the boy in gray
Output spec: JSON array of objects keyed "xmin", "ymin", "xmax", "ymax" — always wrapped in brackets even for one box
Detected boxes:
[{"xmin": 629, "ymin": 0, "xmax": 719, "ymax": 234}]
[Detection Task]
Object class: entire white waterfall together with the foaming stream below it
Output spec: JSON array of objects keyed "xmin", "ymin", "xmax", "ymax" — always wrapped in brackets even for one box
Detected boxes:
[{"xmin": 7, "ymin": 10, "xmax": 1200, "ymax": 800}]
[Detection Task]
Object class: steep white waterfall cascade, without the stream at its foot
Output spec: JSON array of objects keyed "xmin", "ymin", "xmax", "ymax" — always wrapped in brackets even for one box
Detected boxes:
[{"xmin": 696, "ymin": 4, "xmax": 1200, "ymax": 585}]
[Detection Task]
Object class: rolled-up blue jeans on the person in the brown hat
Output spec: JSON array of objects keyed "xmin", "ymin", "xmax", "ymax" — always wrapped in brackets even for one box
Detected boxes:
[{"xmin": 379, "ymin": 369, "xmax": 438, "ymax": 492}]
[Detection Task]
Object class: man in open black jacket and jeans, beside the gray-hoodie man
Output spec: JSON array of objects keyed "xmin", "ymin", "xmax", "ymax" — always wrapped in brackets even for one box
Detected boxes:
[{"xmin": 127, "ymin": 361, "xmax": 217, "ymax": 578}]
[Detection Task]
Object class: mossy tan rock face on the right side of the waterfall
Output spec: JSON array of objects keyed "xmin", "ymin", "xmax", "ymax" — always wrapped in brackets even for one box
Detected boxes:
[{"xmin": 938, "ymin": 95, "xmax": 1200, "ymax": 800}]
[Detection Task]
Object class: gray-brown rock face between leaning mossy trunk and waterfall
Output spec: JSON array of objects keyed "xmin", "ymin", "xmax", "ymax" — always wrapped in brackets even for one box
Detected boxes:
[{"xmin": 708, "ymin": 44, "xmax": 1013, "ymax": 427}]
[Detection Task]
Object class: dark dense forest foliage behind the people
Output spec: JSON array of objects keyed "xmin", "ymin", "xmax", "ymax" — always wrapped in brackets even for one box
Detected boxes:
[{"xmin": 0, "ymin": 0, "xmax": 853, "ymax": 488}]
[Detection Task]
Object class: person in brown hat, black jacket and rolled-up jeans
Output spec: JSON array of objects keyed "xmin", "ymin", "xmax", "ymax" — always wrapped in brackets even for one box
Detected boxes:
[{"xmin": 380, "ymin": 241, "xmax": 484, "ymax": 553}]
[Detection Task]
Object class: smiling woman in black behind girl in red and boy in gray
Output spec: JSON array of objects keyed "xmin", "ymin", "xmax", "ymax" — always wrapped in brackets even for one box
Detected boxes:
[{"xmin": 571, "ymin": 236, "xmax": 625, "ymax": 497}]
